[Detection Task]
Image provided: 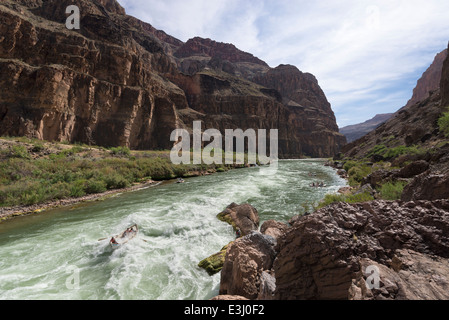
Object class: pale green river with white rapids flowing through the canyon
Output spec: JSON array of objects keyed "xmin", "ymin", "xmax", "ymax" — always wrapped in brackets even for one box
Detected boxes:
[{"xmin": 0, "ymin": 160, "xmax": 346, "ymax": 300}]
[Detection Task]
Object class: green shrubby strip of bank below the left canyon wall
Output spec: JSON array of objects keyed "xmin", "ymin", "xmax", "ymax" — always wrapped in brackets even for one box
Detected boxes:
[{"xmin": 0, "ymin": 138, "xmax": 247, "ymax": 207}]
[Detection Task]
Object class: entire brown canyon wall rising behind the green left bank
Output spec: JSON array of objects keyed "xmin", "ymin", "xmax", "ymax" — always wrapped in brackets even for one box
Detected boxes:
[{"xmin": 0, "ymin": 0, "xmax": 346, "ymax": 158}]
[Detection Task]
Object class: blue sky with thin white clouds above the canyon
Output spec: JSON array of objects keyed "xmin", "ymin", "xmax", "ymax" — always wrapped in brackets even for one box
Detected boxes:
[{"xmin": 118, "ymin": 0, "xmax": 449, "ymax": 127}]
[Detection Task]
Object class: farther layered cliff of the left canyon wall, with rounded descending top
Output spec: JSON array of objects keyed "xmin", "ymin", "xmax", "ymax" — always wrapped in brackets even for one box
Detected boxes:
[{"xmin": 170, "ymin": 38, "xmax": 346, "ymax": 158}]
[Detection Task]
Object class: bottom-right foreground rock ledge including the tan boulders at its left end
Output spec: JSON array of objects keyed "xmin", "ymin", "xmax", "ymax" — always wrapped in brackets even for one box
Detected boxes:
[{"xmin": 213, "ymin": 200, "xmax": 449, "ymax": 300}]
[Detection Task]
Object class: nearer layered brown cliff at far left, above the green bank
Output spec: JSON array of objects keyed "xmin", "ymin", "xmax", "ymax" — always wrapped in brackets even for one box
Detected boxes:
[{"xmin": 0, "ymin": 1, "xmax": 188, "ymax": 149}]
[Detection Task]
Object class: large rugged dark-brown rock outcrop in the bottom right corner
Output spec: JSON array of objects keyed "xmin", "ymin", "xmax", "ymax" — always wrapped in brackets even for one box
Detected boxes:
[{"xmin": 274, "ymin": 200, "xmax": 449, "ymax": 300}]
